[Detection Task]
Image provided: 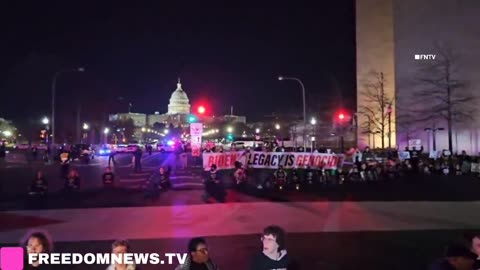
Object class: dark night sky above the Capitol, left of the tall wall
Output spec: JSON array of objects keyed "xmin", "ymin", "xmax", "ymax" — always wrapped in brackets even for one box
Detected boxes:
[{"xmin": 0, "ymin": 0, "xmax": 355, "ymax": 133}]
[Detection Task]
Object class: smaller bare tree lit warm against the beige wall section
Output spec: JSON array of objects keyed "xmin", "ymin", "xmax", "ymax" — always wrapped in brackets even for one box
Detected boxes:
[{"xmin": 358, "ymin": 71, "xmax": 393, "ymax": 148}]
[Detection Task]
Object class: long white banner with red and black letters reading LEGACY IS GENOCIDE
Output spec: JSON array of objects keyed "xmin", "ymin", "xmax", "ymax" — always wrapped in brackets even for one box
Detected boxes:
[{"xmin": 203, "ymin": 151, "xmax": 344, "ymax": 170}]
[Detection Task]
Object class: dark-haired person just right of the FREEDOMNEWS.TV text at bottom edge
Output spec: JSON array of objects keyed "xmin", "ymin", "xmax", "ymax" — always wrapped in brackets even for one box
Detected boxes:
[{"xmin": 175, "ymin": 238, "xmax": 218, "ymax": 270}]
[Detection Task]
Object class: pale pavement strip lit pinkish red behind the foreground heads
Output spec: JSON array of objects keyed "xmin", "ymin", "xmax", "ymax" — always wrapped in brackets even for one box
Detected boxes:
[{"xmin": 0, "ymin": 202, "xmax": 480, "ymax": 243}]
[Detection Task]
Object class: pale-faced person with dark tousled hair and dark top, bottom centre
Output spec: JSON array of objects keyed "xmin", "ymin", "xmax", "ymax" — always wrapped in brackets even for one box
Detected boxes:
[{"xmin": 250, "ymin": 225, "xmax": 297, "ymax": 270}]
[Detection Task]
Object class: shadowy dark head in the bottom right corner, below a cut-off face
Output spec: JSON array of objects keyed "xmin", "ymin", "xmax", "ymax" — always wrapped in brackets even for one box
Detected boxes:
[{"xmin": 429, "ymin": 244, "xmax": 477, "ymax": 270}]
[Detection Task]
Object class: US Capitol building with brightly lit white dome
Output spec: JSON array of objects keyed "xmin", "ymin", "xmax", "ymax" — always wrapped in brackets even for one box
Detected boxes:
[{"xmin": 109, "ymin": 79, "xmax": 246, "ymax": 127}]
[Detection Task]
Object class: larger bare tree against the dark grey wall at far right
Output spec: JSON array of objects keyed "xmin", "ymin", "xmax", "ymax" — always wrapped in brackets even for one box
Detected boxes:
[{"xmin": 414, "ymin": 45, "xmax": 476, "ymax": 152}]
